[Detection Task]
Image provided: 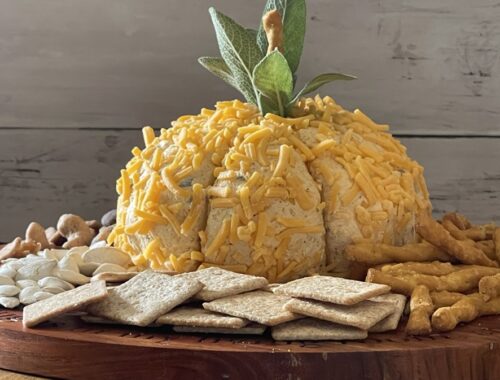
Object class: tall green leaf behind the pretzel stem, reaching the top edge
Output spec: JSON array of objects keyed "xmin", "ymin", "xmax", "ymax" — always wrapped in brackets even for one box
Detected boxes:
[{"xmin": 257, "ymin": 0, "xmax": 306, "ymax": 73}]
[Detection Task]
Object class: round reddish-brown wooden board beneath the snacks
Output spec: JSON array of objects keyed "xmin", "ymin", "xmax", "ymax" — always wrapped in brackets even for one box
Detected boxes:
[{"xmin": 0, "ymin": 310, "xmax": 500, "ymax": 380}]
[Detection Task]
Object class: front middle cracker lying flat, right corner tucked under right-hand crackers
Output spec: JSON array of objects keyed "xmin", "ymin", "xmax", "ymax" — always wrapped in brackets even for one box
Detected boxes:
[{"xmin": 203, "ymin": 290, "xmax": 301, "ymax": 326}]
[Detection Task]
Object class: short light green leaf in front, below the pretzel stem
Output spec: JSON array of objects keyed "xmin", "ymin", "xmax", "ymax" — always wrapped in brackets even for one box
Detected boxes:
[{"xmin": 253, "ymin": 50, "xmax": 293, "ymax": 116}]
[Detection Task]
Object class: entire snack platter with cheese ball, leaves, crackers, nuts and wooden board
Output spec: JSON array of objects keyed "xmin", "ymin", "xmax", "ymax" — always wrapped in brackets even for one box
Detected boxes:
[{"xmin": 0, "ymin": 0, "xmax": 500, "ymax": 379}]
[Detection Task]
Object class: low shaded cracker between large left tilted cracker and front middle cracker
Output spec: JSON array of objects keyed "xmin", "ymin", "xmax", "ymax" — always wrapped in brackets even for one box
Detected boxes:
[{"xmin": 156, "ymin": 306, "xmax": 248, "ymax": 329}]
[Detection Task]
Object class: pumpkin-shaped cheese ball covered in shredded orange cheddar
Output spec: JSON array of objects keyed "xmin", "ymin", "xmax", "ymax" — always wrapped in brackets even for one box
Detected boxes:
[{"xmin": 109, "ymin": 96, "xmax": 430, "ymax": 281}]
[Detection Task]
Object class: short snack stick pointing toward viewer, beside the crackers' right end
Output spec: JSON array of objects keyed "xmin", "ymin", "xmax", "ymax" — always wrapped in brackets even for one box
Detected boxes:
[{"xmin": 406, "ymin": 285, "xmax": 434, "ymax": 335}]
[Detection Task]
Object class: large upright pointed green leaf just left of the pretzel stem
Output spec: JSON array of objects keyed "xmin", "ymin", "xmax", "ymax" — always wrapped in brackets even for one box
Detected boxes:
[{"xmin": 209, "ymin": 8, "xmax": 263, "ymax": 104}]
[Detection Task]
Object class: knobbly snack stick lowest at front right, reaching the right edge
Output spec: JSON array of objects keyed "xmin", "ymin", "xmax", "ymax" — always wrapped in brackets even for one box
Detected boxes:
[{"xmin": 432, "ymin": 293, "xmax": 500, "ymax": 331}]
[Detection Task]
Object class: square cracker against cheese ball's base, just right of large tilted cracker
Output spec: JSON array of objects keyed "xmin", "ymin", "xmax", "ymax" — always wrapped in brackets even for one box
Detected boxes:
[{"xmin": 180, "ymin": 267, "xmax": 268, "ymax": 301}]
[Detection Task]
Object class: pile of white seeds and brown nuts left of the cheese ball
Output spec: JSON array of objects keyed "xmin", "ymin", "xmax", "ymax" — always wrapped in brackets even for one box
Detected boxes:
[{"xmin": 0, "ymin": 210, "xmax": 127, "ymax": 308}]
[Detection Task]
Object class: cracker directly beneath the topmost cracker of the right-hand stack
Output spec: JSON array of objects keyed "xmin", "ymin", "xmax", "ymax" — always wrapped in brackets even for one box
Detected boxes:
[{"xmin": 285, "ymin": 298, "xmax": 395, "ymax": 330}]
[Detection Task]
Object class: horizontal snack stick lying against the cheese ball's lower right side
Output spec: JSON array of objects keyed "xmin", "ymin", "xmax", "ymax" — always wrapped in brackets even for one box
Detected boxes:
[{"xmin": 346, "ymin": 242, "xmax": 450, "ymax": 266}]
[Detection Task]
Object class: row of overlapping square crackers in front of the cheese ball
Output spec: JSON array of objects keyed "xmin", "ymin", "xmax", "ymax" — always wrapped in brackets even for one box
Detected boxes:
[{"xmin": 23, "ymin": 267, "xmax": 405, "ymax": 340}]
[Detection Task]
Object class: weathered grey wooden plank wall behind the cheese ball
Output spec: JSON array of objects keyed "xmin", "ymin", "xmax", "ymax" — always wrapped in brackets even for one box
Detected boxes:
[{"xmin": 0, "ymin": 0, "xmax": 500, "ymax": 240}]
